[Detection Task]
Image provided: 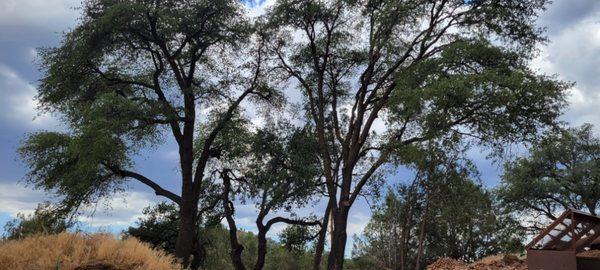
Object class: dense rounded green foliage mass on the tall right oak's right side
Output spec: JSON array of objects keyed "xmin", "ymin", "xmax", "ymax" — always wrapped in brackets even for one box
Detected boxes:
[{"xmin": 388, "ymin": 39, "xmax": 568, "ymax": 149}]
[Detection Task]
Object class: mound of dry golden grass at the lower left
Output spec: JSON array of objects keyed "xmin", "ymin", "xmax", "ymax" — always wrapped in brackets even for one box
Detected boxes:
[{"xmin": 0, "ymin": 233, "xmax": 181, "ymax": 270}]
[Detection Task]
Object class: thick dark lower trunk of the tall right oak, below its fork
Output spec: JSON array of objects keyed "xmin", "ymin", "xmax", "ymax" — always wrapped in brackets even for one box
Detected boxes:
[{"xmin": 327, "ymin": 206, "xmax": 350, "ymax": 270}]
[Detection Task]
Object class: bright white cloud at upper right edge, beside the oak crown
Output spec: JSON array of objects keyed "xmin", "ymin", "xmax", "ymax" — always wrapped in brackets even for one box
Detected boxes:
[{"xmin": 531, "ymin": 0, "xmax": 600, "ymax": 130}]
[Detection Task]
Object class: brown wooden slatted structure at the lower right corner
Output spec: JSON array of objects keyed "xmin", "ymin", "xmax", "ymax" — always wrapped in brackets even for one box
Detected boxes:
[{"xmin": 526, "ymin": 209, "xmax": 600, "ymax": 270}]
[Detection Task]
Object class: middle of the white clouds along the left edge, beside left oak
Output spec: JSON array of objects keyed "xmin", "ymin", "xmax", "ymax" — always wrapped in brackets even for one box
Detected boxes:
[{"xmin": 0, "ymin": 63, "xmax": 58, "ymax": 127}]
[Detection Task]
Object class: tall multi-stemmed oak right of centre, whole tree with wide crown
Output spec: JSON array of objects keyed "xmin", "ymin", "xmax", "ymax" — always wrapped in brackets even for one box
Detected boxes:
[{"xmin": 265, "ymin": 0, "xmax": 568, "ymax": 269}]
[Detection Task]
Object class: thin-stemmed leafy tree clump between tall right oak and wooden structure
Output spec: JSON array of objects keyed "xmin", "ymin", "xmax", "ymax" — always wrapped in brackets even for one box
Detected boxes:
[{"xmin": 353, "ymin": 143, "xmax": 522, "ymax": 269}]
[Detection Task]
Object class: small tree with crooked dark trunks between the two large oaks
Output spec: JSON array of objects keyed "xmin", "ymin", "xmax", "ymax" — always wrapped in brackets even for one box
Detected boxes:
[{"xmin": 220, "ymin": 122, "xmax": 320, "ymax": 270}]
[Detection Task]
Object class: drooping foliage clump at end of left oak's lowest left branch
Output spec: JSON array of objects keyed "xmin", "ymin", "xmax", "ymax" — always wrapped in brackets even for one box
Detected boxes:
[{"xmin": 19, "ymin": 131, "xmax": 130, "ymax": 213}]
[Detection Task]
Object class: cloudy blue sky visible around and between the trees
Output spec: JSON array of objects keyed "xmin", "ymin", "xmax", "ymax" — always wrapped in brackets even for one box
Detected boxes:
[{"xmin": 0, "ymin": 0, "xmax": 600, "ymax": 252}]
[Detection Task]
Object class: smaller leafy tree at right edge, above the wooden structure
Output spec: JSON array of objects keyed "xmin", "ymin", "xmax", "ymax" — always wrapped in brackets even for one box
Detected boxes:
[{"xmin": 498, "ymin": 124, "xmax": 600, "ymax": 230}]
